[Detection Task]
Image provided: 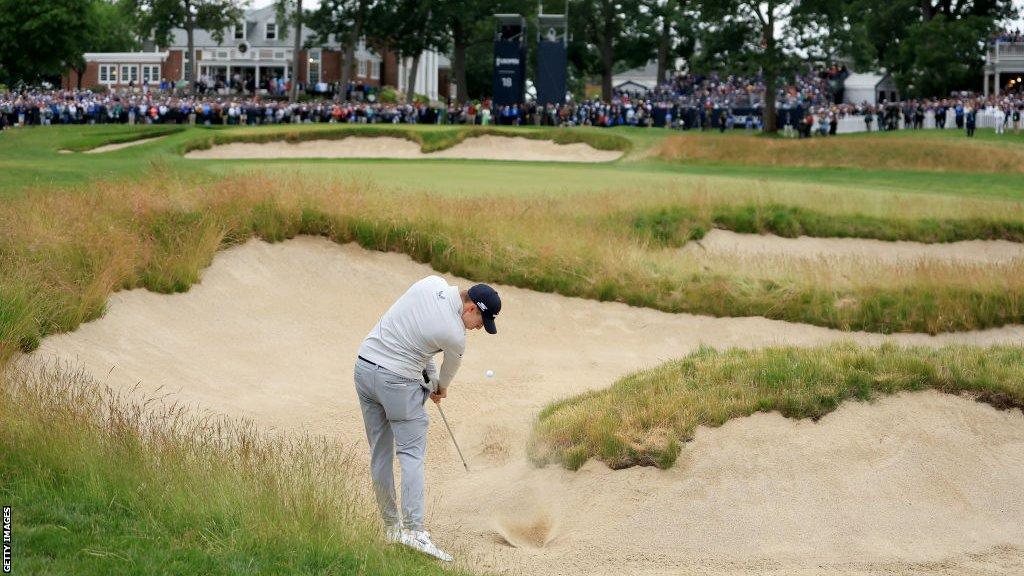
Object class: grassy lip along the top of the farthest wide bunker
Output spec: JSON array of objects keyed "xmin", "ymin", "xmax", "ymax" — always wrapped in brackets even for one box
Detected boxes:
[{"xmin": 181, "ymin": 124, "xmax": 631, "ymax": 154}]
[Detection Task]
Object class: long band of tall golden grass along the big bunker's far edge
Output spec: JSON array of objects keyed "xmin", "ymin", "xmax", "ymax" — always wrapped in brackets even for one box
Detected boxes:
[{"xmin": 0, "ymin": 173, "xmax": 1024, "ymax": 358}]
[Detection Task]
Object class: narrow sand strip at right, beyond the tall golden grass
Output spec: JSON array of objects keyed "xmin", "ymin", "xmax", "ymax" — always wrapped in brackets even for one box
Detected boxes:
[{"xmin": 683, "ymin": 230, "xmax": 1024, "ymax": 264}]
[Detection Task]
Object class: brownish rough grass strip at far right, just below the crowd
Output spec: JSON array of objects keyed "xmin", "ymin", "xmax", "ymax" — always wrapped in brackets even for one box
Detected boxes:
[{"xmin": 651, "ymin": 134, "xmax": 1024, "ymax": 174}]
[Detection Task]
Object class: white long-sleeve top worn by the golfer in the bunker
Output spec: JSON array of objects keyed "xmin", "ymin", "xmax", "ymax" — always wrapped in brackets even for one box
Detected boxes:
[{"xmin": 359, "ymin": 276, "xmax": 466, "ymax": 392}]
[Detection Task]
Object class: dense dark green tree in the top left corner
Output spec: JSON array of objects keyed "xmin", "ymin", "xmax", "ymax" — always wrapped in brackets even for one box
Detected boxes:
[{"xmin": 0, "ymin": 0, "xmax": 89, "ymax": 84}]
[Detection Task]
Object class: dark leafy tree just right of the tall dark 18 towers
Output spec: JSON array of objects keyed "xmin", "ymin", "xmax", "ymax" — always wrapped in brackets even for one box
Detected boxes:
[{"xmin": 568, "ymin": 0, "xmax": 654, "ymax": 100}]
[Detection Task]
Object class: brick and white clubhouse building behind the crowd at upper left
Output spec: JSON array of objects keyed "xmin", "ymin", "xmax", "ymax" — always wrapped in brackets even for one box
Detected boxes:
[{"xmin": 63, "ymin": 6, "xmax": 451, "ymax": 99}]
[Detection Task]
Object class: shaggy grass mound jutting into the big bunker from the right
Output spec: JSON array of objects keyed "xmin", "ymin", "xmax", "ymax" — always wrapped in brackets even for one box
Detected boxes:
[{"xmin": 528, "ymin": 343, "xmax": 1024, "ymax": 469}]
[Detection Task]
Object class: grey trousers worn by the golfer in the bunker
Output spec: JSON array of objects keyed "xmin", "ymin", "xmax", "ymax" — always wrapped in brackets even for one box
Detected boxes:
[{"xmin": 355, "ymin": 360, "xmax": 430, "ymax": 530}]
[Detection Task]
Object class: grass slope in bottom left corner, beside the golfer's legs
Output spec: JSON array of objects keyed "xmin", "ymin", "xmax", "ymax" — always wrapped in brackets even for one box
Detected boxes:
[{"xmin": 0, "ymin": 365, "xmax": 471, "ymax": 576}]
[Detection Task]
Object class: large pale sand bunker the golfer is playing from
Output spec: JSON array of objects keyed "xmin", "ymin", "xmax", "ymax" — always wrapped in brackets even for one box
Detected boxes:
[{"xmin": 24, "ymin": 238, "xmax": 1024, "ymax": 576}]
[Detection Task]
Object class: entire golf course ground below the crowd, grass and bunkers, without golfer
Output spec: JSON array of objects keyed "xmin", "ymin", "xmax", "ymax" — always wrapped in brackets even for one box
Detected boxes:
[{"xmin": 0, "ymin": 123, "xmax": 1024, "ymax": 576}]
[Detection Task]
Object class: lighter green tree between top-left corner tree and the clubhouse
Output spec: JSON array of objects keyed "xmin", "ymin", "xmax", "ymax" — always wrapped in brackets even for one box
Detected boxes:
[{"xmin": 69, "ymin": 0, "xmax": 140, "ymax": 90}]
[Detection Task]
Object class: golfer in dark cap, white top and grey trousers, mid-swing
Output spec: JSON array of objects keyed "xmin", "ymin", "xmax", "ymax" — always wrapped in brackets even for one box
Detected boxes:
[{"xmin": 355, "ymin": 276, "xmax": 502, "ymax": 562}]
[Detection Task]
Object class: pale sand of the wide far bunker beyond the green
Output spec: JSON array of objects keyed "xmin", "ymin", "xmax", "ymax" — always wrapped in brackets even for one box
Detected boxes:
[{"xmin": 185, "ymin": 135, "xmax": 623, "ymax": 162}]
